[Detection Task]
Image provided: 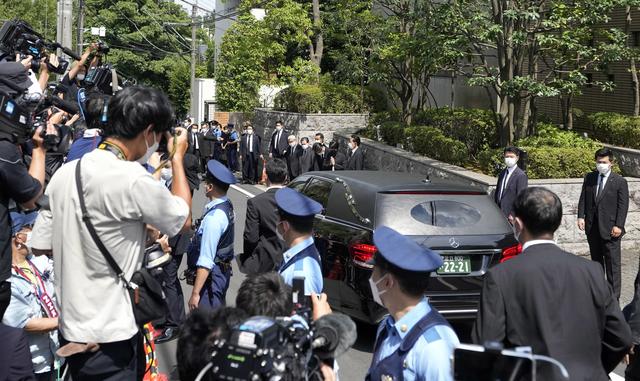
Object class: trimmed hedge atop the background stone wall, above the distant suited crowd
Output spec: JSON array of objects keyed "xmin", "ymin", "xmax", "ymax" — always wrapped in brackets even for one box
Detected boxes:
[{"xmin": 275, "ymin": 83, "xmax": 367, "ymax": 114}]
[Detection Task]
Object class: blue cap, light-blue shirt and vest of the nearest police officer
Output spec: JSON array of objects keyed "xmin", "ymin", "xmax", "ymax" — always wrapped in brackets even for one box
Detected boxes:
[{"xmin": 366, "ymin": 226, "xmax": 459, "ymax": 381}]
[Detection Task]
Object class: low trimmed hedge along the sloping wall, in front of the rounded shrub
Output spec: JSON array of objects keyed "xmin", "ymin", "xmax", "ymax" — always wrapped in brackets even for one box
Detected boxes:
[{"xmin": 404, "ymin": 126, "xmax": 468, "ymax": 166}]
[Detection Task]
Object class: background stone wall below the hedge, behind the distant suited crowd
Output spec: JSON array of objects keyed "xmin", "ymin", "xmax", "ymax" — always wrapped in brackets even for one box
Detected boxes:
[{"xmin": 253, "ymin": 108, "xmax": 368, "ymax": 149}]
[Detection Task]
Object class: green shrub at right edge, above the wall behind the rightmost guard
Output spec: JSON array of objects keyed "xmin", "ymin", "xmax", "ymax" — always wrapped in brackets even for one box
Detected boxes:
[{"xmin": 588, "ymin": 112, "xmax": 640, "ymax": 149}]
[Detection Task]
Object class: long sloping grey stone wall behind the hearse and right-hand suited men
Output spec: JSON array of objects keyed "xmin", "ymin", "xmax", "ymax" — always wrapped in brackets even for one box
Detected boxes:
[{"xmin": 334, "ymin": 133, "xmax": 640, "ymax": 254}]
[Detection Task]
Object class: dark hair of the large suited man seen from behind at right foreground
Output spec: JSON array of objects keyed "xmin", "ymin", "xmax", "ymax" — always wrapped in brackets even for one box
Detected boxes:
[{"xmin": 513, "ymin": 187, "xmax": 562, "ymax": 236}]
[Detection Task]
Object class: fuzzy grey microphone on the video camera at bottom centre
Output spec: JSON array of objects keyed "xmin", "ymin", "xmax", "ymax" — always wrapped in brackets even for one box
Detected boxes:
[{"xmin": 311, "ymin": 313, "xmax": 358, "ymax": 360}]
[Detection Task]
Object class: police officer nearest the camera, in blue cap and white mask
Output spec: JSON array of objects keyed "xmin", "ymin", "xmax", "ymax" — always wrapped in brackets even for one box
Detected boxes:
[{"xmin": 366, "ymin": 226, "xmax": 459, "ymax": 381}]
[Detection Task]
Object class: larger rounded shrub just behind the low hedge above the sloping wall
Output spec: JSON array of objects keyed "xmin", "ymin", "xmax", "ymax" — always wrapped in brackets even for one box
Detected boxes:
[{"xmin": 414, "ymin": 107, "xmax": 500, "ymax": 159}]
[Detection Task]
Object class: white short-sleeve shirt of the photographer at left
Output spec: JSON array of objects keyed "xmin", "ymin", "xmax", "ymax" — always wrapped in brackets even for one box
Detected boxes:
[{"xmin": 31, "ymin": 149, "xmax": 189, "ymax": 343}]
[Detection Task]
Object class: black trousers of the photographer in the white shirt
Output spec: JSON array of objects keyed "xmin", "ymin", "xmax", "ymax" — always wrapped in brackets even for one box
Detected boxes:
[{"xmin": 60, "ymin": 333, "xmax": 146, "ymax": 381}]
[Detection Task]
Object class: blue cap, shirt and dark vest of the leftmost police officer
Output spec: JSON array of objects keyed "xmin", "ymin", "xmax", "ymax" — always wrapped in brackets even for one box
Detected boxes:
[{"xmin": 194, "ymin": 160, "xmax": 236, "ymax": 309}]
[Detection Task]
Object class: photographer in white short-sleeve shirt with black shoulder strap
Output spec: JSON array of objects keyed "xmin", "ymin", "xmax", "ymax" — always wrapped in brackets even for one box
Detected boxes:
[{"xmin": 32, "ymin": 86, "xmax": 191, "ymax": 380}]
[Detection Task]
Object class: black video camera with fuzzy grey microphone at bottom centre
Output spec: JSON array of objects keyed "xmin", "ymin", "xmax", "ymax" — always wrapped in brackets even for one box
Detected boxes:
[{"xmin": 196, "ymin": 278, "xmax": 357, "ymax": 381}]
